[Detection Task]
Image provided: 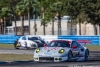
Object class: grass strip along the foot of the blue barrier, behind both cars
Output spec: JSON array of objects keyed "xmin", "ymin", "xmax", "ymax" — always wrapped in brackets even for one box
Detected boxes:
[{"xmin": 0, "ymin": 44, "xmax": 100, "ymax": 50}]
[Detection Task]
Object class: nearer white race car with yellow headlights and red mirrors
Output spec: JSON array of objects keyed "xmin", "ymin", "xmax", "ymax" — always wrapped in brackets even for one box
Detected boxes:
[{"xmin": 34, "ymin": 39, "xmax": 89, "ymax": 62}]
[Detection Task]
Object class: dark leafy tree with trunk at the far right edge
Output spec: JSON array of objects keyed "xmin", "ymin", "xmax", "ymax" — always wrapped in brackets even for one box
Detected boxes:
[{"xmin": 86, "ymin": 0, "xmax": 100, "ymax": 35}]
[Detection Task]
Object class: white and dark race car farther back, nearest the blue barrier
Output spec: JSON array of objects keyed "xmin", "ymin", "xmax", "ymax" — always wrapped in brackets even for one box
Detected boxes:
[{"xmin": 14, "ymin": 35, "xmax": 45, "ymax": 49}]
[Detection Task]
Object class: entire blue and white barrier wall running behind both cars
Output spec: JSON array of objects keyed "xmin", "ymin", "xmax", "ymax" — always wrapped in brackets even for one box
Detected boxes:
[{"xmin": 0, "ymin": 35, "xmax": 100, "ymax": 45}]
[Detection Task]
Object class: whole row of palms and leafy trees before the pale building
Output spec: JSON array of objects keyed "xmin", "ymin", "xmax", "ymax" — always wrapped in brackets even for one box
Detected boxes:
[{"xmin": 0, "ymin": 0, "xmax": 100, "ymax": 35}]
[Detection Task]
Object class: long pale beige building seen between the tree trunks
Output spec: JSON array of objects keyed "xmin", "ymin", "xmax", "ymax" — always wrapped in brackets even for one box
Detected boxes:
[{"xmin": 7, "ymin": 16, "xmax": 99, "ymax": 35}]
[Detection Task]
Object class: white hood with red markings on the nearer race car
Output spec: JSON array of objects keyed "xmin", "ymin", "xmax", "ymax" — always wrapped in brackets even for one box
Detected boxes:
[{"xmin": 34, "ymin": 47, "xmax": 70, "ymax": 57}]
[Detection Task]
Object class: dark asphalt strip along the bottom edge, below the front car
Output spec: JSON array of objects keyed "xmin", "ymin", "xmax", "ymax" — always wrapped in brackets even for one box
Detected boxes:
[{"xmin": 0, "ymin": 61, "xmax": 100, "ymax": 67}]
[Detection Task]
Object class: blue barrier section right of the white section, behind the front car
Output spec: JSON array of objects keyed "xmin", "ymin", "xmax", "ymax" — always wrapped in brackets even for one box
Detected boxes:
[{"xmin": 58, "ymin": 36, "xmax": 100, "ymax": 45}]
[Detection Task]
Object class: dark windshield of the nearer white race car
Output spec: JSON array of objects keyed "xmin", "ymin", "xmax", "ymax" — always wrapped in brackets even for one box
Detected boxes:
[{"xmin": 46, "ymin": 41, "xmax": 70, "ymax": 47}]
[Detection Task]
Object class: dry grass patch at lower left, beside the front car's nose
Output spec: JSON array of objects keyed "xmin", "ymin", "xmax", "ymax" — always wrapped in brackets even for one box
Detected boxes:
[{"xmin": 0, "ymin": 54, "xmax": 33, "ymax": 61}]
